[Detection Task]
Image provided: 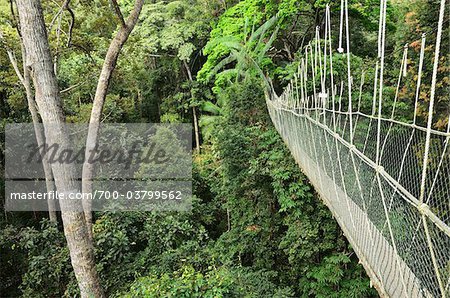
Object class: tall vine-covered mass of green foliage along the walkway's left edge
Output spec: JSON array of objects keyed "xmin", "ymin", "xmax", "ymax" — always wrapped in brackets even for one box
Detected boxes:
[{"xmin": 194, "ymin": 80, "xmax": 374, "ymax": 297}]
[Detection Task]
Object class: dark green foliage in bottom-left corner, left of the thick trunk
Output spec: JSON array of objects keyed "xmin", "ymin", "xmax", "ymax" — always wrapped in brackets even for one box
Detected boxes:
[{"xmin": 0, "ymin": 220, "xmax": 75, "ymax": 297}]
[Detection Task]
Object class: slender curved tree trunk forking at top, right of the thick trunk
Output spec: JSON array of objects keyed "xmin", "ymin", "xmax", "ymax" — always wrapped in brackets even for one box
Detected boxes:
[{"xmin": 81, "ymin": 0, "xmax": 144, "ymax": 237}]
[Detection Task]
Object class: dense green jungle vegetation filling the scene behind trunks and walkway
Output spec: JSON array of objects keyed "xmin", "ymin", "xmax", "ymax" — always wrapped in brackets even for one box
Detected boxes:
[{"xmin": 0, "ymin": 0, "xmax": 449, "ymax": 298}]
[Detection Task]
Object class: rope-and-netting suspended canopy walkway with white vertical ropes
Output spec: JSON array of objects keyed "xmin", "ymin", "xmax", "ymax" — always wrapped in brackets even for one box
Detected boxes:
[{"xmin": 266, "ymin": 0, "xmax": 450, "ymax": 297}]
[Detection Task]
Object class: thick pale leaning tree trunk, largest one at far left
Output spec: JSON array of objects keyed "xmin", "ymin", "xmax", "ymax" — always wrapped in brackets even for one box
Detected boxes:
[{"xmin": 17, "ymin": 0, "xmax": 104, "ymax": 297}]
